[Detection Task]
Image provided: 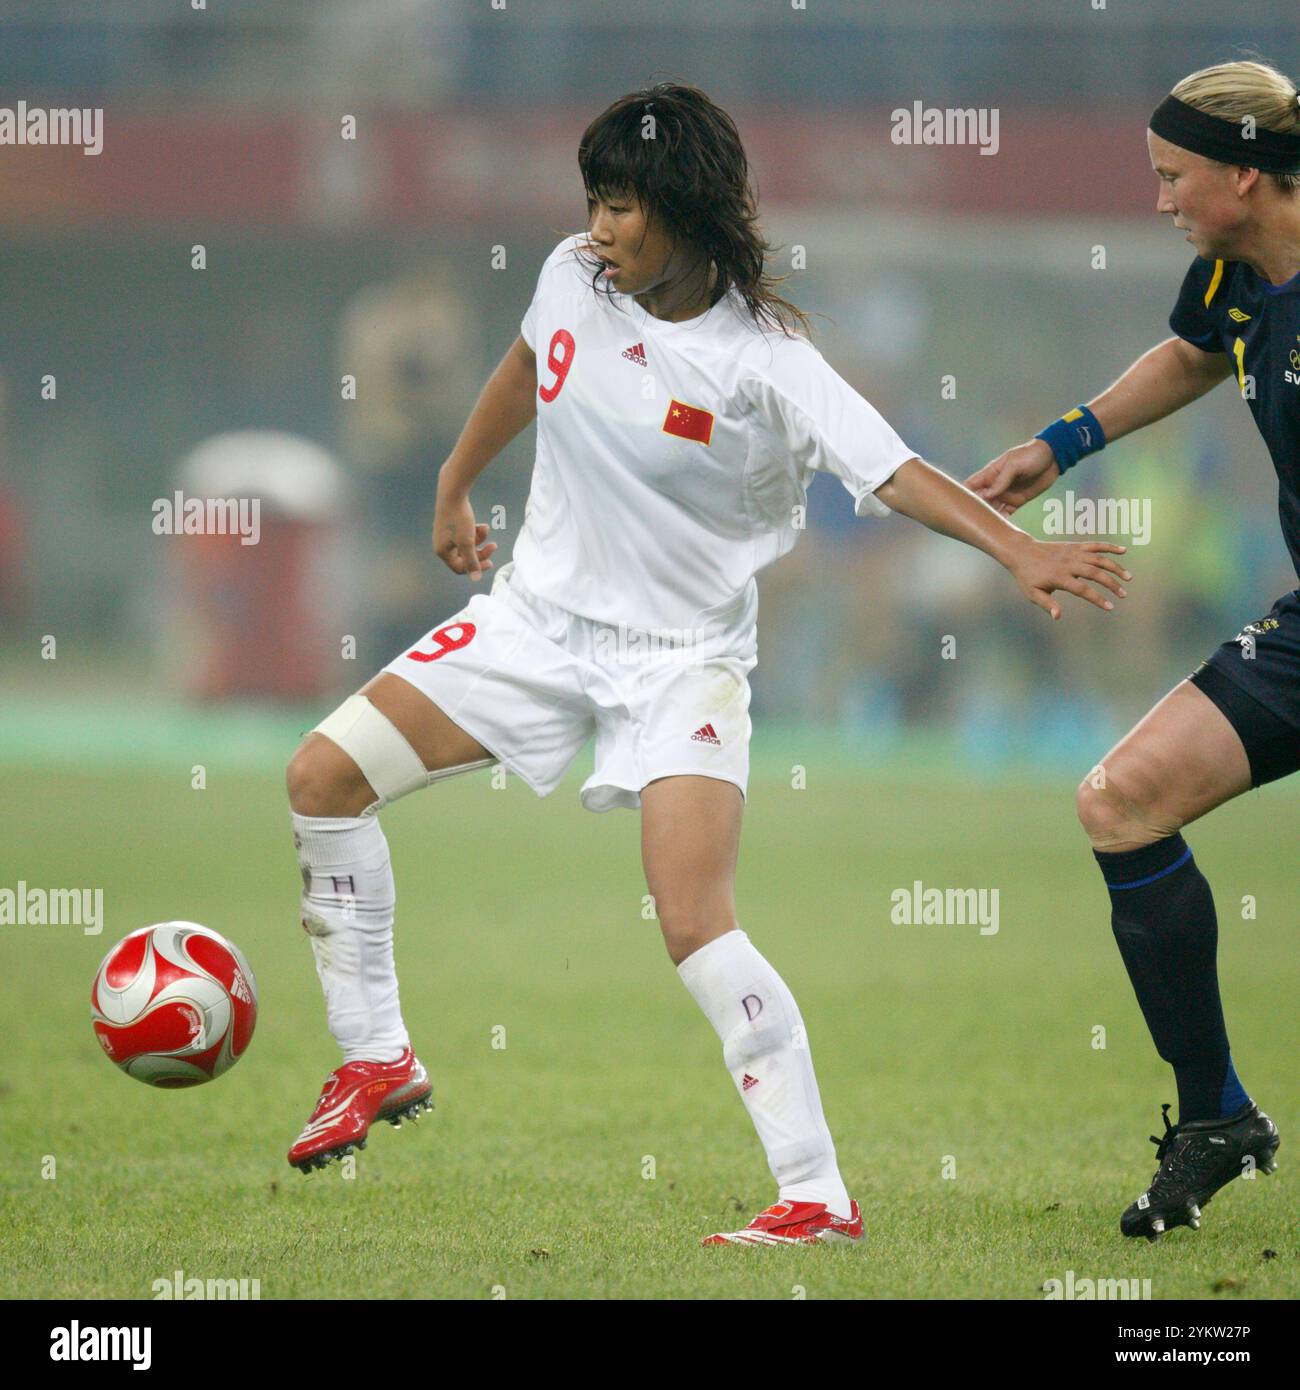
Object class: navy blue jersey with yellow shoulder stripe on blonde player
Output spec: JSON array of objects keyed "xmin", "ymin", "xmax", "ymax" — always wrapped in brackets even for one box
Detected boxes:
[{"xmin": 1169, "ymin": 257, "xmax": 1300, "ymax": 575}]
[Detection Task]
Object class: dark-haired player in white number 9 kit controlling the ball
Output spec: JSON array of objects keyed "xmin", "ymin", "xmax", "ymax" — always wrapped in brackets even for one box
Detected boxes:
[{"xmin": 288, "ymin": 83, "xmax": 1129, "ymax": 1244}]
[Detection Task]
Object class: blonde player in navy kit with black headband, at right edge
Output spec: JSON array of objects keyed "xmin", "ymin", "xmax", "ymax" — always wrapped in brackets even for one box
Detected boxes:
[{"xmin": 968, "ymin": 63, "xmax": 1300, "ymax": 1240}]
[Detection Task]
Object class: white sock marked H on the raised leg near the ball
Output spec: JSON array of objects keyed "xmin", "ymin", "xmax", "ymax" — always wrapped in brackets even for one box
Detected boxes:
[{"xmin": 293, "ymin": 812, "xmax": 409, "ymax": 1063}]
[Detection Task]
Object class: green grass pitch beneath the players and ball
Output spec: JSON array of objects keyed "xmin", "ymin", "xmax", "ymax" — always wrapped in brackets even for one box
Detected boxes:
[{"xmin": 0, "ymin": 758, "xmax": 1300, "ymax": 1300}]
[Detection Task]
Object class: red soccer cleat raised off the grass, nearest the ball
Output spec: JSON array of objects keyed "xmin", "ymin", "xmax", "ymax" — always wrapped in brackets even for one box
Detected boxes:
[{"xmin": 289, "ymin": 1048, "xmax": 434, "ymax": 1173}]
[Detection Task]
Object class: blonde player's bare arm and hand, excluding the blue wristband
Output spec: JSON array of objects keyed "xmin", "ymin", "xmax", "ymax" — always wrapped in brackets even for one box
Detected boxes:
[{"xmin": 966, "ymin": 338, "xmax": 1232, "ymax": 516}]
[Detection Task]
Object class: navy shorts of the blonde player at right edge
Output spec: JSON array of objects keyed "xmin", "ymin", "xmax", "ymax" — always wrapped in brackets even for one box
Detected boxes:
[{"xmin": 1189, "ymin": 589, "xmax": 1300, "ymax": 787}]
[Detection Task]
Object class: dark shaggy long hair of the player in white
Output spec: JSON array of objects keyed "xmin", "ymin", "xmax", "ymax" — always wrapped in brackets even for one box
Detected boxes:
[{"xmin": 578, "ymin": 82, "xmax": 811, "ymax": 336}]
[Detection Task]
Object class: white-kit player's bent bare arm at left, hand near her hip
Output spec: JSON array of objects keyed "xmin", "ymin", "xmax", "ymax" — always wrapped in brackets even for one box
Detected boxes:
[{"xmin": 434, "ymin": 338, "xmax": 537, "ymax": 580}]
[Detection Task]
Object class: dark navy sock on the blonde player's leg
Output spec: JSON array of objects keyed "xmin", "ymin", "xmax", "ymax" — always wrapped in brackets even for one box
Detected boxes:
[{"xmin": 1093, "ymin": 834, "xmax": 1250, "ymax": 1123}]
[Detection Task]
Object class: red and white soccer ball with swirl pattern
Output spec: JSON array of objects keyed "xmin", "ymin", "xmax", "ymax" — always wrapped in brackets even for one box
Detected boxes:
[{"xmin": 90, "ymin": 922, "xmax": 257, "ymax": 1087}]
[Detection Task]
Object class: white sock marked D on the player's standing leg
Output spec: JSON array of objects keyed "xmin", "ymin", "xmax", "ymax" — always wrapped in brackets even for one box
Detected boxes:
[{"xmin": 677, "ymin": 930, "xmax": 850, "ymax": 1218}]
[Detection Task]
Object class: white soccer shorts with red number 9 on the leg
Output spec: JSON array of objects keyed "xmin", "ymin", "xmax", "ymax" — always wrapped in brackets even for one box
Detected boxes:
[{"xmin": 384, "ymin": 564, "xmax": 758, "ymax": 810}]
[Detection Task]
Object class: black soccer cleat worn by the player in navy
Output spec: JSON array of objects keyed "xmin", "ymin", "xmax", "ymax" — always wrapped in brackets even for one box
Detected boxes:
[{"xmin": 1119, "ymin": 1101, "xmax": 1281, "ymax": 1243}]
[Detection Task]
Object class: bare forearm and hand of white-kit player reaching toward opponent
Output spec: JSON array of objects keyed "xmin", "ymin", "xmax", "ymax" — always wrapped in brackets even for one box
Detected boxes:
[{"xmin": 876, "ymin": 459, "xmax": 1133, "ymax": 619}]
